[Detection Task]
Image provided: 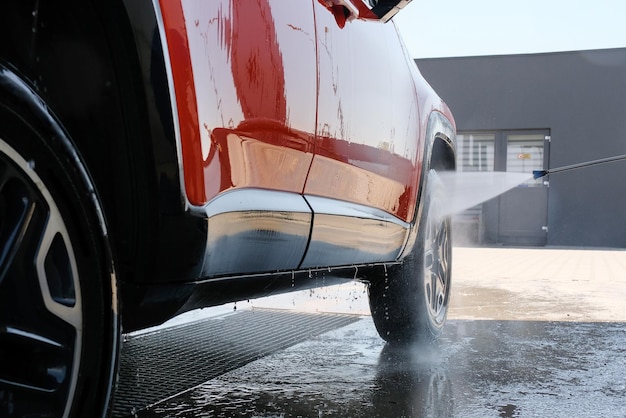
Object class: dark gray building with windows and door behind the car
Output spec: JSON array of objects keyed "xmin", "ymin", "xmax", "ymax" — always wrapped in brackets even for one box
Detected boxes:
[{"xmin": 416, "ymin": 48, "xmax": 626, "ymax": 248}]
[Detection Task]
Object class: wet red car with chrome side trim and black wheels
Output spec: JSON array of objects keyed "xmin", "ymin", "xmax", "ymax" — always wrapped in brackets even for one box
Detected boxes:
[{"xmin": 0, "ymin": 0, "xmax": 456, "ymax": 417}]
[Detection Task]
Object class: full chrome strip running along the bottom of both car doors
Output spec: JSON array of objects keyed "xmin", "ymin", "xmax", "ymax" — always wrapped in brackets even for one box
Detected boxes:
[{"xmin": 196, "ymin": 189, "xmax": 410, "ymax": 278}]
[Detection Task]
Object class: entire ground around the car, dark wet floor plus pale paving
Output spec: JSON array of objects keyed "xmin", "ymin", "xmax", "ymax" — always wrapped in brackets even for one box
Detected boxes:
[{"xmin": 114, "ymin": 247, "xmax": 626, "ymax": 417}]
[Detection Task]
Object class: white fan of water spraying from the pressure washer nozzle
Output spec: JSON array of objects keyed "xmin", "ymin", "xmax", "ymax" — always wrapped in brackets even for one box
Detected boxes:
[{"xmin": 437, "ymin": 171, "xmax": 533, "ymax": 215}]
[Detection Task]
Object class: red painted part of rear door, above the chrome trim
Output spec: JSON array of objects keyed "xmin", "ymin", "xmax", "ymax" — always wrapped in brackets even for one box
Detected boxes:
[{"xmin": 305, "ymin": 3, "xmax": 423, "ymax": 222}]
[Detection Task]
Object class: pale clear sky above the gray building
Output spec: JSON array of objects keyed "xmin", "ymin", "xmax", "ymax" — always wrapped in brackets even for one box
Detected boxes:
[{"xmin": 394, "ymin": 0, "xmax": 626, "ymax": 58}]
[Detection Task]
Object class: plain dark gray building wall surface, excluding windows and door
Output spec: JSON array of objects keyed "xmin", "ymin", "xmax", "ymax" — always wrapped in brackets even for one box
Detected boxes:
[{"xmin": 416, "ymin": 48, "xmax": 626, "ymax": 248}]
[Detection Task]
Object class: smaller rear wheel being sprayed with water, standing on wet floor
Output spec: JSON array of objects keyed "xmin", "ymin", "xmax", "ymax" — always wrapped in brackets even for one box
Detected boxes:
[{"xmin": 368, "ymin": 170, "xmax": 452, "ymax": 343}]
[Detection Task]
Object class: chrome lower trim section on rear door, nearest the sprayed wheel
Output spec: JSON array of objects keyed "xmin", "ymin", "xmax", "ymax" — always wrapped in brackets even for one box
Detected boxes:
[{"xmin": 300, "ymin": 195, "xmax": 410, "ymax": 269}]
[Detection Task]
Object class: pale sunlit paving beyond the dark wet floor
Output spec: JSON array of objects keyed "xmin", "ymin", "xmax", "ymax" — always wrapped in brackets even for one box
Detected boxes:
[{"xmin": 243, "ymin": 247, "xmax": 626, "ymax": 321}]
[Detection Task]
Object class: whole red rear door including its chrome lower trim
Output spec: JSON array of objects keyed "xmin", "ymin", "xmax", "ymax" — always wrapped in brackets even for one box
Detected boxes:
[{"xmin": 303, "ymin": 1, "xmax": 423, "ymax": 267}]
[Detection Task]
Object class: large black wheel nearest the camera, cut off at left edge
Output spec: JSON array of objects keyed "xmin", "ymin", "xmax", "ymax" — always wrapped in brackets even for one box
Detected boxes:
[{"xmin": 0, "ymin": 67, "xmax": 120, "ymax": 417}]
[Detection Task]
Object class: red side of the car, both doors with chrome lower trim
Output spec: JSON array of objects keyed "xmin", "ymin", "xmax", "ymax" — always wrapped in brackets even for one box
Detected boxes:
[{"xmin": 155, "ymin": 0, "xmax": 438, "ymax": 277}]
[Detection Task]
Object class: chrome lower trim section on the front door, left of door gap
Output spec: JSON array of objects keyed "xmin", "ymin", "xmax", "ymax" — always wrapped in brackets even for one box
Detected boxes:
[{"xmin": 202, "ymin": 189, "xmax": 313, "ymax": 277}]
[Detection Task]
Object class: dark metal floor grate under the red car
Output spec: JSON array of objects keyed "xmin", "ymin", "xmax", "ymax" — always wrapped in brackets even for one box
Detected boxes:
[{"xmin": 113, "ymin": 309, "xmax": 360, "ymax": 417}]
